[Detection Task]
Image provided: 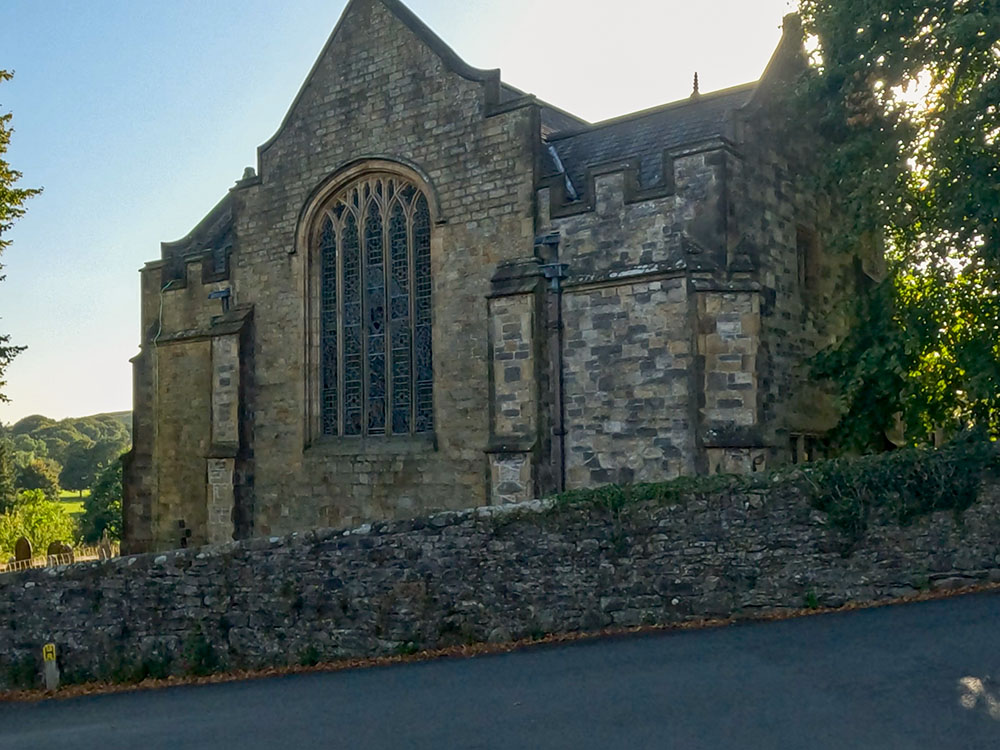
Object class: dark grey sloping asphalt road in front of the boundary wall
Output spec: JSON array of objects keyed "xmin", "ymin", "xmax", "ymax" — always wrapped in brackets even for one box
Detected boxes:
[{"xmin": 0, "ymin": 594, "xmax": 1000, "ymax": 750}]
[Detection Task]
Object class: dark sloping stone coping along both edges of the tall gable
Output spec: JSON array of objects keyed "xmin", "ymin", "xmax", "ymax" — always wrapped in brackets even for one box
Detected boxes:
[{"xmin": 257, "ymin": 0, "xmax": 520, "ymax": 165}]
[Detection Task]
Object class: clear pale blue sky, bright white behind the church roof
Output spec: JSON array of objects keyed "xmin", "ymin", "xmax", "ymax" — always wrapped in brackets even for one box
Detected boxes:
[{"xmin": 0, "ymin": 0, "xmax": 792, "ymax": 423}]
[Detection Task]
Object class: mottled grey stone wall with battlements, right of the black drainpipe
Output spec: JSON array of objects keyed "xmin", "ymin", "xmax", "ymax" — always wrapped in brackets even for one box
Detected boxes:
[{"xmin": 538, "ymin": 151, "xmax": 736, "ymax": 488}]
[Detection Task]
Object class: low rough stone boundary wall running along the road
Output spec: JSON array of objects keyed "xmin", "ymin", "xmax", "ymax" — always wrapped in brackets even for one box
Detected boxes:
[{"xmin": 0, "ymin": 487, "xmax": 1000, "ymax": 692}]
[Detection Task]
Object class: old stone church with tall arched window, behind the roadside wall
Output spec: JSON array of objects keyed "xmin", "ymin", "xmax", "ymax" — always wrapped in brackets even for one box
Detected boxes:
[{"xmin": 124, "ymin": 0, "xmax": 855, "ymax": 551}]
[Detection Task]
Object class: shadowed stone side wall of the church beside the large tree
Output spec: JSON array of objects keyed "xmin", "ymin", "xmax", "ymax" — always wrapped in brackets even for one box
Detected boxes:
[{"xmin": 732, "ymin": 108, "xmax": 858, "ymax": 461}]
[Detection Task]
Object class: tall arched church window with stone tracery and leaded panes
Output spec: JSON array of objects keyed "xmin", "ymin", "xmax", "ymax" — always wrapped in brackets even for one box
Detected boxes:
[{"xmin": 317, "ymin": 174, "xmax": 434, "ymax": 436}]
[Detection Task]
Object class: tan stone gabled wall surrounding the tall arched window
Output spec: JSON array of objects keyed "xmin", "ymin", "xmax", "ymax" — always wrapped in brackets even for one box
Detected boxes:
[{"xmin": 233, "ymin": 2, "xmax": 537, "ymax": 535}]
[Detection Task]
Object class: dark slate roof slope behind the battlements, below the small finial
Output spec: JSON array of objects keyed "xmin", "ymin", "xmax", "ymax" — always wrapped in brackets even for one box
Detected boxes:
[{"xmin": 542, "ymin": 83, "xmax": 757, "ymax": 198}]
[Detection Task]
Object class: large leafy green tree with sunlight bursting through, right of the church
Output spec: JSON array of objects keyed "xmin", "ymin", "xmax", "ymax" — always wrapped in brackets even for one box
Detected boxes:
[{"xmin": 792, "ymin": 0, "xmax": 1000, "ymax": 449}]
